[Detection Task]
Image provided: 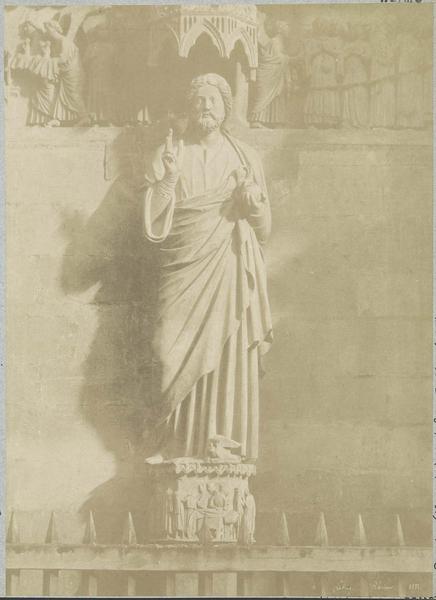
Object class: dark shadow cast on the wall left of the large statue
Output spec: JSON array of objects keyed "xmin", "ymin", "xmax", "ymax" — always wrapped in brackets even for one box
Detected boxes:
[{"xmin": 61, "ymin": 130, "xmax": 169, "ymax": 543}]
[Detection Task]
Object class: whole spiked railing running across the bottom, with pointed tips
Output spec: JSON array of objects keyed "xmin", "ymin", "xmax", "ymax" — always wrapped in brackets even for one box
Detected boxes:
[{"xmin": 6, "ymin": 512, "xmax": 431, "ymax": 597}]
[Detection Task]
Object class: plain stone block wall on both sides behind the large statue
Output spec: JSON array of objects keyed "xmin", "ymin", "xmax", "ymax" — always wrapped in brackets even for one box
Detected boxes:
[{"xmin": 6, "ymin": 128, "xmax": 432, "ymax": 544}]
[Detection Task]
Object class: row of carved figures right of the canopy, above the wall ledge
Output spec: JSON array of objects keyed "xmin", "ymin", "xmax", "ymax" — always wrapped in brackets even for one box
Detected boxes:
[{"xmin": 249, "ymin": 19, "xmax": 432, "ymax": 128}]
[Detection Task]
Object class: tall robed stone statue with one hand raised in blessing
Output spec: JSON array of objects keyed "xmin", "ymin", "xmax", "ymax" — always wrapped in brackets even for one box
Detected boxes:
[{"xmin": 144, "ymin": 74, "xmax": 272, "ymax": 463}]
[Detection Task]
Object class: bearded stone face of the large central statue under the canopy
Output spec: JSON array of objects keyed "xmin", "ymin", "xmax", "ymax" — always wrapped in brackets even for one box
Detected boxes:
[{"xmin": 191, "ymin": 85, "xmax": 226, "ymax": 134}]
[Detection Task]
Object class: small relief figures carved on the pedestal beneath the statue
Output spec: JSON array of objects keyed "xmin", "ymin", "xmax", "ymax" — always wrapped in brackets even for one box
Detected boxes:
[{"xmin": 160, "ymin": 482, "xmax": 256, "ymax": 544}]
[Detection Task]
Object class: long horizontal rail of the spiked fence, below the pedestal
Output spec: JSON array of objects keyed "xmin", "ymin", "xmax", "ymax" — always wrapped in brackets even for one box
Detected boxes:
[{"xmin": 6, "ymin": 544, "xmax": 432, "ymax": 574}]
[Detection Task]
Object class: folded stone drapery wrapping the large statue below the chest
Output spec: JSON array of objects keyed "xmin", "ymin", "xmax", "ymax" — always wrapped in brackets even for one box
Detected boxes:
[{"xmin": 145, "ymin": 135, "xmax": 272, "ymax": 457}]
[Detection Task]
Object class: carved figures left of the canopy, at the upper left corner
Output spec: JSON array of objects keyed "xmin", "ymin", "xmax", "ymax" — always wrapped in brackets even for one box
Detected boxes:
[{"xmin": 5, "ymin": 9, "xmax": 149, "ymax": 126}]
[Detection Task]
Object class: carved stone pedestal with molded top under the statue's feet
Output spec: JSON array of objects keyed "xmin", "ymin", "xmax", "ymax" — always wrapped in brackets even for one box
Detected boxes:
[{"xmin": 146, "ymin": 459, "xmax": 256, "ymax": 544}]
